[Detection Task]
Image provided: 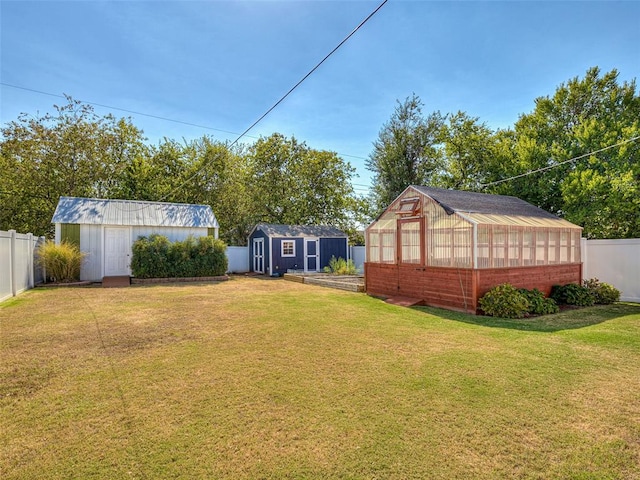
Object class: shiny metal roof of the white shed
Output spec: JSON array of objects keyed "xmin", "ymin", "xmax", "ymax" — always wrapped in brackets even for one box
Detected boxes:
[{"xmin": 51, "ymin": 197, "xmax": 219, "ymax": 228}]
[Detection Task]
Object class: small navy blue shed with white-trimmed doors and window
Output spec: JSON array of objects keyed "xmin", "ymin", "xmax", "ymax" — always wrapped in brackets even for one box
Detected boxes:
[{"xmin": 248, "ymin": 223, "xmax": 349, "ymax": 275}]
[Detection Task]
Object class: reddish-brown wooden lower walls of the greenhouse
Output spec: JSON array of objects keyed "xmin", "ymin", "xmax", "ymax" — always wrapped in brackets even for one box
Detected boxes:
[{"xmin": 365, "ymin": 262, "xmax": 582, "ymax": 313}]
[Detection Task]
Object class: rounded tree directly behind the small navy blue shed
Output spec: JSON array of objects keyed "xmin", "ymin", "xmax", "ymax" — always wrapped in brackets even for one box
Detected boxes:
[{"xmin": 248, "ymin": 133, "xmax": 355, "ymax": 234}]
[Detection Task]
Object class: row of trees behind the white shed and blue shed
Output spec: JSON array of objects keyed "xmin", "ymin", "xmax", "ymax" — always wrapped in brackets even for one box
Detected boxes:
[{"xmin": 0, "ymin": 98, "xmax": 364, "ymax": 245}]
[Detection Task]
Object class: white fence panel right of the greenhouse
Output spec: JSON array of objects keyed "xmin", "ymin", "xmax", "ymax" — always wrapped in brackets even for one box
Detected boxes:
[{"xmin": 582, "ymin": 238, "xmax": 640, "ymax": 302}]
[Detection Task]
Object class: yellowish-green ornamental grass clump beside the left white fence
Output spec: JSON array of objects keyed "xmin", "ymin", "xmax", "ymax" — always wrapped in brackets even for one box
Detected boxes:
[{"xmin": 38, "ymin": 240, "xmax": 86, "ymax": 282}]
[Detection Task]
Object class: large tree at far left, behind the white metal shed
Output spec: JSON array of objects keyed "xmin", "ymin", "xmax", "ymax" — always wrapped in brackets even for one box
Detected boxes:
[{"xmin": 0, "ymin": 97, "xmax": 146, "ymax": 235}]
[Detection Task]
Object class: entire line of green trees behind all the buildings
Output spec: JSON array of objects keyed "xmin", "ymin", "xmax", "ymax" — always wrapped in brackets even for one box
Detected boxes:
[{"xmin": 0, "ymin": 68, "xmax": 640, "ymax": 240}]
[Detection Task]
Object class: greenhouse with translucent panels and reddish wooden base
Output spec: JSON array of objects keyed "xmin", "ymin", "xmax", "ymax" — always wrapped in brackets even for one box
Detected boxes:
[{"xmin": 365, "ymin": 185, "xmax": 582, "ymax": 313}]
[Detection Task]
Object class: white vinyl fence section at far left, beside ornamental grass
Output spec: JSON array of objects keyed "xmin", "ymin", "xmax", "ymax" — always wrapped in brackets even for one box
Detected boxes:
[{"xmin": 0, "ymin": 230, "xmax": 44, "ymax": 302}]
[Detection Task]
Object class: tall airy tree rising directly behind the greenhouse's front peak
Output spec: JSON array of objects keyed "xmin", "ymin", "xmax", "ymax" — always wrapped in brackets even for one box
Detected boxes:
[{"xmin": 367, "ymin": 94, "xmax": 443, "ymax": 211}]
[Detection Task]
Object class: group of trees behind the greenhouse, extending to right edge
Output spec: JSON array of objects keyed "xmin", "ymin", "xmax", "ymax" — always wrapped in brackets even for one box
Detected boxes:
[{"xmin": 368, "ymin": 68, "xmax": 640, "ymax": 238}]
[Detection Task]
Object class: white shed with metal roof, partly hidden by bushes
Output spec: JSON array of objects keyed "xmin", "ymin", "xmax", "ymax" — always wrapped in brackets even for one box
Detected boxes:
[{"xmin": 51, "ymin": 197, "xmax": 218, "ymax": 281}]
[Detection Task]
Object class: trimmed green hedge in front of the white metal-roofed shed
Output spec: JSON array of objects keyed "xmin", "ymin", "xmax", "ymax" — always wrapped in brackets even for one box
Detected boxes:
[{"xmin": 131, "ymin": 234, "xmax": 228, "ymax": 278}]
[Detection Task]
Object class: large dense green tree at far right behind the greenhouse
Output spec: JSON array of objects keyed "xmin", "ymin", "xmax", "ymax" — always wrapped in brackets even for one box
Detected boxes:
[{"xmin": 500, "ymin": 67, "xmax": 640, "ymax": 238}]
